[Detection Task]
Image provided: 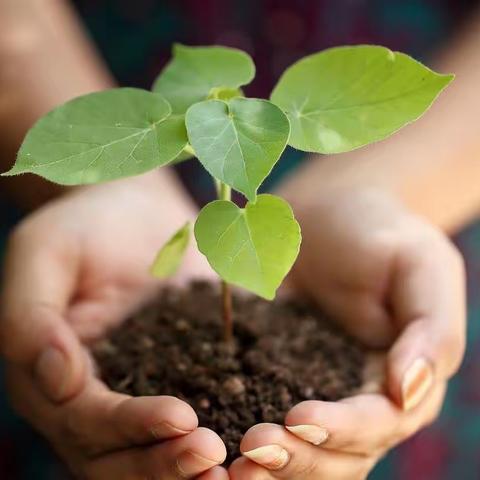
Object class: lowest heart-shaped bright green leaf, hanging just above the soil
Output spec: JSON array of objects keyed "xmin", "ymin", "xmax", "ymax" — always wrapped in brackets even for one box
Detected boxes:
[{"xmin": 195, "ymin": 195, "xmax": 301, "ymax": 300}]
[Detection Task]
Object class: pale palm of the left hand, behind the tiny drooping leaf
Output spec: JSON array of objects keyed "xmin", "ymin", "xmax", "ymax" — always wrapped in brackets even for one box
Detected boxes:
[{"xmin": 25, "ymin": 180, "xmax": 208, "ymax": 341}]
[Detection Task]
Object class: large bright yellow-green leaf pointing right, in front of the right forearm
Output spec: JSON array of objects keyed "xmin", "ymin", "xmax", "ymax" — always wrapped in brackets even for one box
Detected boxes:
[{"xmin": 271, "ymin": 45, "xmax": 453, "ymax": 153}]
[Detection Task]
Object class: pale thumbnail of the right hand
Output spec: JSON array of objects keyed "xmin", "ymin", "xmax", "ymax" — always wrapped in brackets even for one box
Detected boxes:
[{"xmin": 402, "ymin": 357, "xmax": 433, "ymax": 411}]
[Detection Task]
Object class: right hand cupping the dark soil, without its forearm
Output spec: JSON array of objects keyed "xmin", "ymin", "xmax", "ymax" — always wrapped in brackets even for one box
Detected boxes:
[{"xmin": 230, "ymin": 190, "xmax": 465, "ymax": 480}]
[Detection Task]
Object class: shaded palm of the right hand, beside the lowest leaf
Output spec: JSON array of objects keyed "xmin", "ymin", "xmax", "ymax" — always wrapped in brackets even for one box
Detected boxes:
[{"xmin": 294, "ymin": 190, "xmax": 403, "ymax": 347}]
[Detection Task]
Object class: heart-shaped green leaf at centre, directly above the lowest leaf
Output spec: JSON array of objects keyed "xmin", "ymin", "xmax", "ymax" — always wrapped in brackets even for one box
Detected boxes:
[{"xmin": 185, "ymin": 98, "xmax": 290, "ymax": 201}]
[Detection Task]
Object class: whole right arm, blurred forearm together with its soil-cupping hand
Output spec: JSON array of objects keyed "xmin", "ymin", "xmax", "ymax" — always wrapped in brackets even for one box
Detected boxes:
[{"xmin": 231, "ymin": 13, "xmax": 472, "ymax": 480}]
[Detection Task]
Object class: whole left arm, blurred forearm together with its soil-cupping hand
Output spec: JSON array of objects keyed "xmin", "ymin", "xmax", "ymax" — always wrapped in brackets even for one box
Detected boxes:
[{"xmin": 0, "ymin": 0, "xmax": 231, "ymax": 480}]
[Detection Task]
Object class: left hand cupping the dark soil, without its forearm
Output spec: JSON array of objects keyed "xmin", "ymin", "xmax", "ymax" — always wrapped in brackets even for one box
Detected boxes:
[{"xmin": 0, "ymin": 172, "xmax": 226, "ymax": 480}]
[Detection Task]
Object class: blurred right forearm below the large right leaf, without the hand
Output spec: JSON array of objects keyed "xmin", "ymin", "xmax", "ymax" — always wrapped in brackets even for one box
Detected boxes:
[{"xmin": 284, "ymin": 12, "xmax": 480, "ymax": 231}]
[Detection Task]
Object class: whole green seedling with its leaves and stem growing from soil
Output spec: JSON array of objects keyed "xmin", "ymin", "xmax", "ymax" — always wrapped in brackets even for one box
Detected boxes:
[{"xmin": 4, "ymin": 45, "xmax": 453, "ymax": 341}]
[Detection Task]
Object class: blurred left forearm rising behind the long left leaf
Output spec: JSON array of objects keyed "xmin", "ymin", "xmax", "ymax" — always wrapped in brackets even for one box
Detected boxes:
[{"xmin": 0, "ymin": 0, "xmax": 114, "ymax": 206}]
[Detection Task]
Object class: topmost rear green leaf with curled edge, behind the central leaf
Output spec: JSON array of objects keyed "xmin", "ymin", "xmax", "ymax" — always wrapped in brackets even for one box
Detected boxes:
[{"xmin": 153, "ymin": 44, "xmax": 255, "ymax": 113}]
